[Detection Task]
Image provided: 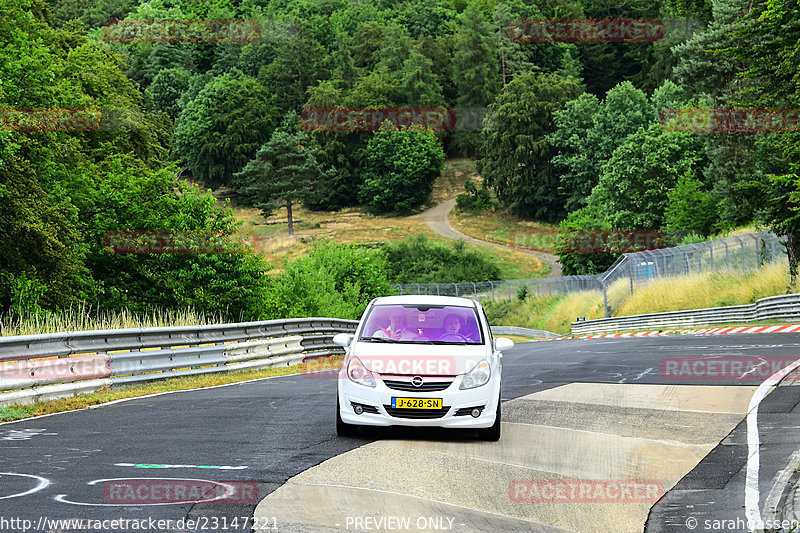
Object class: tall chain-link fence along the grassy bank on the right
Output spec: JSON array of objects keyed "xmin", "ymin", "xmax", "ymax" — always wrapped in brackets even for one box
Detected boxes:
[{"xmin": 393, "ymin": 231, "xmax": 786, "ymax": 316}]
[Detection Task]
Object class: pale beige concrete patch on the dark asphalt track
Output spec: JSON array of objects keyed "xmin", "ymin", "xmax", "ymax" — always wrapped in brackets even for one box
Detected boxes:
[{"xmin": 255, "ymin": 383, "xmax": 755, "ymax": 533}]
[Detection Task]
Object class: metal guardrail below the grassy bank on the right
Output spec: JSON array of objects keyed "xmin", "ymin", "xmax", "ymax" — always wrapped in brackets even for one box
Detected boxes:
[{"xmin": 571, "ymin": 294, "xmax": 800, "ymax": 335}]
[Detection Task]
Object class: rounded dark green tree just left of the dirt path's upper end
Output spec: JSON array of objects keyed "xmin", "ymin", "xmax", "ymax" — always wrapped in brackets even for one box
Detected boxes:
[{"xmin": 358, "ymin": 129, "xmax": 444, "ymax": 213}]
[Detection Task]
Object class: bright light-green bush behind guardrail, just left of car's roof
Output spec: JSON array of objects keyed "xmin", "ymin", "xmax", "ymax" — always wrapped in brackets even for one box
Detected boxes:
[{"xmin": 265, "ymin": 241, "xmax": 391, "ymax": 319}]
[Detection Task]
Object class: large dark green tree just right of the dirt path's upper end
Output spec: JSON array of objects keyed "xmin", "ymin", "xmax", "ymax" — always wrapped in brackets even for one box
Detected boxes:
[{"xmin": 479, "ymin": 72, "xmax": 580, "ymax": 221}]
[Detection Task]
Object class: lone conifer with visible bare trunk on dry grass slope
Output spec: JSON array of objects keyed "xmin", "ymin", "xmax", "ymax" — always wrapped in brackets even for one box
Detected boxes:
[{"xmin": 235, "ymin": 113, "xmax": 332, "ymax": 235}]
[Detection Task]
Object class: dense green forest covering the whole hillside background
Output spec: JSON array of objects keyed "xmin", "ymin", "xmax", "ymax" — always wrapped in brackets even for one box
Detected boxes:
[{"xmin": 0, "ymin": 0, "xmax": 800, "ymax": 319}]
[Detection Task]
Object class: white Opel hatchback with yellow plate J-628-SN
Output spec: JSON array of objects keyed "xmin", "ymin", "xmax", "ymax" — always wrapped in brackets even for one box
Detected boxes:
[{"xmin": 333, "ymin": 296, "xmax": 514, "ymax": 440}]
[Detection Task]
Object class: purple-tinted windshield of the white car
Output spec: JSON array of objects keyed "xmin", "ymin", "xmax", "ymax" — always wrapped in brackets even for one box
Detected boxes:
[{"xmin": 360, "ymin": 304, "xmax": 483, "ymax": 344}]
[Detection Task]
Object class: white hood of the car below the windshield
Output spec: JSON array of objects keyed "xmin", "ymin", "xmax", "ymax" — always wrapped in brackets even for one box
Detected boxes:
[{"xmin": 350, "ymin": 342, "xmax": 490, "ymax": 376}]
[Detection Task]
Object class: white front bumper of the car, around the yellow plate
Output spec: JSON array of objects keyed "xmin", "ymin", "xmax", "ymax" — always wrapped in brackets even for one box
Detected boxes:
[{"xmin": 339, "ymin": 375, "xmax": 500, "ymax": 428}]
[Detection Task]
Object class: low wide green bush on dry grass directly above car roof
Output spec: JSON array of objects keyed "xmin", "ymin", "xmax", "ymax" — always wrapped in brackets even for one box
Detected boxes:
[{"xmin": 384, "ymin": 234, "xmax": 500, "ymax": 283}]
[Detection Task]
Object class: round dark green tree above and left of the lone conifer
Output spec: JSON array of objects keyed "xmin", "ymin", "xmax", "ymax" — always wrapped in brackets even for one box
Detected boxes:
[{"xmin": 175, "ymin": 70, "xmax": 276, "ymax": 187}]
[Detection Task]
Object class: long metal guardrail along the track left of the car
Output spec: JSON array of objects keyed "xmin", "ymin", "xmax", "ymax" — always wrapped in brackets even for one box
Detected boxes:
[{"xmin": 0, "ymin": 318, "xmax": 358, "ymax": 405}]
